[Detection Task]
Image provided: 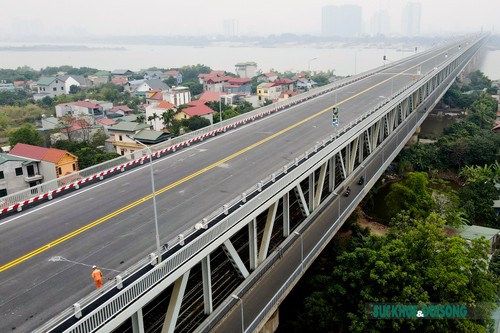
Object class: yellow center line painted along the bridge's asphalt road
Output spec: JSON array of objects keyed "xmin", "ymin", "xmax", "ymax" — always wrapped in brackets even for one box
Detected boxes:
[{"xmin": 0, "ymin": 55, "xmax": 428, "ymax": 272}]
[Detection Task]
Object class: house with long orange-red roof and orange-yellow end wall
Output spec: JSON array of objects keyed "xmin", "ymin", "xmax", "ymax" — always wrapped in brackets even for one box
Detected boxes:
[{"xmin": 10, "ymin": 143, "xmax": 78, "ymax": 182}]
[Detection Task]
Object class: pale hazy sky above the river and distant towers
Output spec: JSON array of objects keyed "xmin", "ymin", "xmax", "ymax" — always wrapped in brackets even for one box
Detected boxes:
[{"xmin": 0, "ymin": 0, "xmax": 500, "ymax": 41}]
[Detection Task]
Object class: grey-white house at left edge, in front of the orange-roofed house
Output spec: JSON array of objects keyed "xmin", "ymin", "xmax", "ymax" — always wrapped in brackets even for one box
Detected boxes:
[{"xmin": 0, "ymin": 153, "xmax": 43, "ymax": 197}]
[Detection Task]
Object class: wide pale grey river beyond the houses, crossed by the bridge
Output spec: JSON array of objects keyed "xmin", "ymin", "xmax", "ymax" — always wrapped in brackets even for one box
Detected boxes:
[{"xmin": 0, "ymin": 43, "xmax": 500, "ymax": 79}]
